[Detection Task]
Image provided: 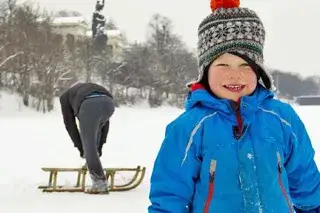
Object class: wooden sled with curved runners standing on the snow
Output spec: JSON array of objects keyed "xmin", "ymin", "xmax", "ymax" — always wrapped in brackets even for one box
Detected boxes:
[{"xmin": 38, "ymin": 166, "xmax": 146, "ymax": 192}]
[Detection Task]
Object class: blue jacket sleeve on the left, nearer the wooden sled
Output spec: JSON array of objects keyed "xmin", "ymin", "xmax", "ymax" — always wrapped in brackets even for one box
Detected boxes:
[{"xmin": 148, "ymin": 117, "xmax": 201, "ymax": 213}]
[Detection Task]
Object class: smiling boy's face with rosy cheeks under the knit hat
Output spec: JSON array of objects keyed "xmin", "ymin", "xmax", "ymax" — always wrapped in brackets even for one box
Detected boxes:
[{"xmin": 208, "ymin": 53, "xmax": 257, "ymax": 101}]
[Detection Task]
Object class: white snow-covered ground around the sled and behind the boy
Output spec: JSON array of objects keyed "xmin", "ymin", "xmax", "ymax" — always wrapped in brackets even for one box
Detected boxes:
[{"xmin": 0, "ymin": 90, "xmax": 320, "ymax": 213}]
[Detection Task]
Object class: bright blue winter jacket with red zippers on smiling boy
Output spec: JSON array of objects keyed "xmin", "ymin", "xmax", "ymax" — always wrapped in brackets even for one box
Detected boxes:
[{"xmin": 148, "ymin": 87, "xmax": 320, "ymax": 213}]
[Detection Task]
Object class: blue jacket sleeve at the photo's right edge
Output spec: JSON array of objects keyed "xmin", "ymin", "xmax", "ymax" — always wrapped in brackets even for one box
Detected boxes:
[{"xmin": 285, "ymin": 106, "xmax": 320, "ymax": 210}]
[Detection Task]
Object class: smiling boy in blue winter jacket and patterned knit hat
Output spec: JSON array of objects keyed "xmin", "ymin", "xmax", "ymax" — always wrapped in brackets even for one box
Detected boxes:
[{"xmin": 148, "ymin": 0, "xmax": 320, "ymax": 213}]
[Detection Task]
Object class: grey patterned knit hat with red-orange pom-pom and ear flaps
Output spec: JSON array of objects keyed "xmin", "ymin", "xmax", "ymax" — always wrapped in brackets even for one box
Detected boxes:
[{"xmin": 187, "ymin": 0, "xmax": 275, "ymax": 90}]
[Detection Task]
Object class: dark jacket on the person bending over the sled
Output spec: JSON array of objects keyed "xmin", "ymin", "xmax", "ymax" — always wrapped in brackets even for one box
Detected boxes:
[{"xmin": 60, "ymin": 83, "xmax": 113, "ymax": 156}]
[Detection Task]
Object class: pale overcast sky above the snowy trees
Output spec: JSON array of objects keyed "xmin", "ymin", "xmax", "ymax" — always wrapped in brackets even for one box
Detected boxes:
[{"xmin": 23, "ymin": 0, "xmax": 320, "ymax": 76}]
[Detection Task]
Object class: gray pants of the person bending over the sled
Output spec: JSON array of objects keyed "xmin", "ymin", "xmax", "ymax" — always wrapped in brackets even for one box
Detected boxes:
[{"xmin": 78, "ymin": 96, "xmax": 115, "ymax": 182}]
